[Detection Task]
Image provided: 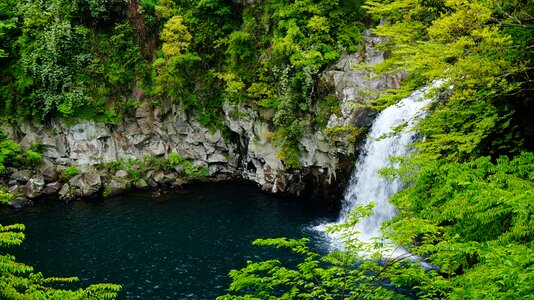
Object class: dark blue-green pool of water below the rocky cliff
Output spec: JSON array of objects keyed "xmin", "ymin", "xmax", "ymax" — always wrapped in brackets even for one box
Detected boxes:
[{"xmin": 0, "ymin": 183, "xmax": 337, "ymax": 299}]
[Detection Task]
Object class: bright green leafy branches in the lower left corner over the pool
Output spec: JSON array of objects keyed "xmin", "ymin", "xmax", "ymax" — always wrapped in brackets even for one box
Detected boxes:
[{"xmin": 0, "ymin": 224, "xmax": 121, "ymax": 300}]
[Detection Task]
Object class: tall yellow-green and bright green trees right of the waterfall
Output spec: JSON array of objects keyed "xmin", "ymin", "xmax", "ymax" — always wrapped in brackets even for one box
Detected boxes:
[{"xmin": 352, "ymin": 0, "xmax": 534, "ymax": 299}]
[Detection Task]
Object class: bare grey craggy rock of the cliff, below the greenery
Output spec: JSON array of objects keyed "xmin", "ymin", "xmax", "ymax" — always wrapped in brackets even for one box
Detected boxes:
[{"xmin": 5, "ymin": 33, "xmax": 400, "ymax": 204}]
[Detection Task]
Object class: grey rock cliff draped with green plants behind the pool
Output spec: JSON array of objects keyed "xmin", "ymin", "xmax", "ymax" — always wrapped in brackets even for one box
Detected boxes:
[{"xmin": 0, "ymin": 0, "xmax": 400, "ymax": 204}]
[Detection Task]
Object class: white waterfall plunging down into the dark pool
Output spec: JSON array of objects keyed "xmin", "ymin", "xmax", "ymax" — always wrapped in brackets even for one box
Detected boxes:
[{"xmin": 339, "ymin": 85, "xmax": 436, "ymax": 241}]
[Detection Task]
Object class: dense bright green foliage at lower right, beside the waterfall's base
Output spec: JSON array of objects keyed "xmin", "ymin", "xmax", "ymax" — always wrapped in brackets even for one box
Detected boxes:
[{"xmin": 388, "ymin": 153, "xmax": 534, "ymax": 299}]
